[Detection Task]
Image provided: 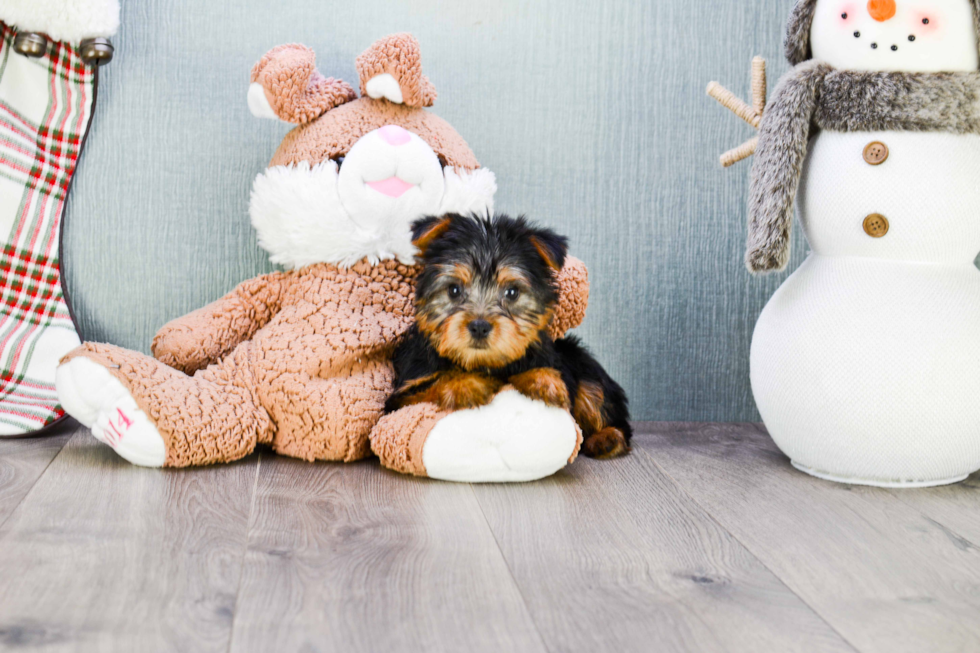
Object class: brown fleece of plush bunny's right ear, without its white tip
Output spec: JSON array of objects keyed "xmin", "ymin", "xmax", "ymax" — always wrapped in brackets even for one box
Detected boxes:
[{"xmin": 357, "ymin": 32, "xmax": 436, "ymax": 107}]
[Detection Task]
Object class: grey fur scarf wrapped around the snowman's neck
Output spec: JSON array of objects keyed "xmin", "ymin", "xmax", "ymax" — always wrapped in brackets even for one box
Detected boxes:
[{"xmin": 745, "ymin": 61, "xmax": 980, "ymax": 273}]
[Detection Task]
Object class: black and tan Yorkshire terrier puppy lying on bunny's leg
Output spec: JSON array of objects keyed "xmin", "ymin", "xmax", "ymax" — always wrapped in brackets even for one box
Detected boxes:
[{"xmin": 385, "ymin": 214, "xmax": 633, "ymax": 458}]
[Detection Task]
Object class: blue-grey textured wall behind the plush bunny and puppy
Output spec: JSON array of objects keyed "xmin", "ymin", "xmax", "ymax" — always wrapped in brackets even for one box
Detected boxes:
[{"xmin": 64, "ymin": 0, "xmax": 804, "ymax": 421}]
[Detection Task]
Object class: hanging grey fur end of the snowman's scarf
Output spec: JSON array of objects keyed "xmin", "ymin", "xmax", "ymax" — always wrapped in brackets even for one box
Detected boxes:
[{"xmin": 745, "ymin": 61, "xmax": 833, "ymax": 273}]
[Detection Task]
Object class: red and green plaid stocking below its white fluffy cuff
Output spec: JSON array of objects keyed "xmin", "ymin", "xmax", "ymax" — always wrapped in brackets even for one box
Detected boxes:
[{"xmin": 0, "ymin": 23, "xmax": 95, "ymax": 435}]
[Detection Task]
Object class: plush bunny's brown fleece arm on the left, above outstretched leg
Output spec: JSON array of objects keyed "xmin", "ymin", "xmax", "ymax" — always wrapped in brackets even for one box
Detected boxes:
[{"xmin": 152, "ymin": 272, "xmax": 292, "ymax": 374}]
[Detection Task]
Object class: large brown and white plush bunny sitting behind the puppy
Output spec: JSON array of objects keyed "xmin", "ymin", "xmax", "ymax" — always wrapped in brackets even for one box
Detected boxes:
[{"xmin": 57, "ymin": 34, "xmax": 588, "ymax": 481}]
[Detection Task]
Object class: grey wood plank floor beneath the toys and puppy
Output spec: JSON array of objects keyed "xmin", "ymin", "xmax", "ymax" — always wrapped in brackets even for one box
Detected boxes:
[{"xmin": 0, "ymin": 424, "xmax": 980, "ymax": 653}]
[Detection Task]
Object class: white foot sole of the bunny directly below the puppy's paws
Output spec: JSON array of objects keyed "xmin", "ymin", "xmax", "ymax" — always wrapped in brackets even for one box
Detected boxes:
[{"xmin": 422, "ymin": 390, "xmax": 578, "ymax": 483}]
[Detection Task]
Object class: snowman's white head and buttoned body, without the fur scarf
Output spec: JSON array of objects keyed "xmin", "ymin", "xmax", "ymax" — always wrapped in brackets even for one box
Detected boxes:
[{"xmin": 751, "ymin": 0, "xmax": 980, "ymax": 486}]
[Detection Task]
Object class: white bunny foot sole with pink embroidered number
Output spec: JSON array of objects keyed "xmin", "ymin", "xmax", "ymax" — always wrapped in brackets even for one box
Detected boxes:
[{"xmin": 55, "ymin": 356, "xmax": 167, "ymax": 467}]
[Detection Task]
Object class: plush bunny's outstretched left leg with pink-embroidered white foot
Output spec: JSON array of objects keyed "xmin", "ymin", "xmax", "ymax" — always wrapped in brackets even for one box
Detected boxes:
[{"xmin": 57, "ymin": 342, "xmax": 271, "ymax": 467}]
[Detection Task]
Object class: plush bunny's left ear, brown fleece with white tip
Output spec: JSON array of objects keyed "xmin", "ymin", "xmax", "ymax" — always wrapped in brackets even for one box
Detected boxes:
[{"xmin": 248, "ymin": 43, "xmax": 357, "ymax": 125}]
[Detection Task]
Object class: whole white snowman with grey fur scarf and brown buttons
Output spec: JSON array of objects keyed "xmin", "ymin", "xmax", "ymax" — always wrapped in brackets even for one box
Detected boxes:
[{"xmin": 746, "ymin": 0, "xmax": 980, "ymax": 487}]
